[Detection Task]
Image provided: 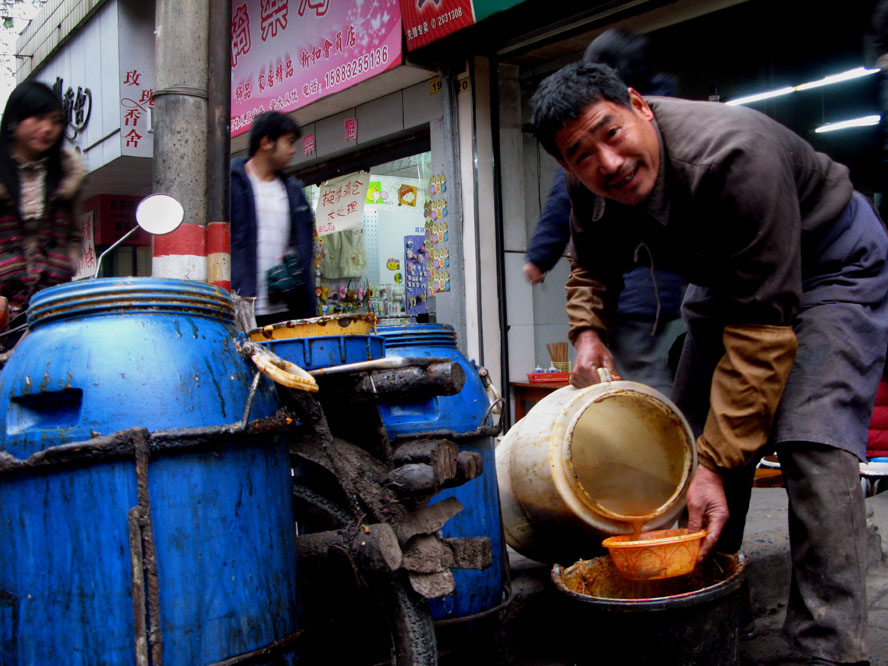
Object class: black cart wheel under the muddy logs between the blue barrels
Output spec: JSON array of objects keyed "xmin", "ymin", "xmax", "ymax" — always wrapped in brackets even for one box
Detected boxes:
[{"xmin": 293, "ymin": 483, "xmax": 438, "ymax": 666}]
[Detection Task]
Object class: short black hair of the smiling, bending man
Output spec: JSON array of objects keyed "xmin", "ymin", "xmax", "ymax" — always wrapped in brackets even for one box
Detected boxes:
[{"xmin": 530, "ymin": 62, "xmax": 632, "ymax": 159}]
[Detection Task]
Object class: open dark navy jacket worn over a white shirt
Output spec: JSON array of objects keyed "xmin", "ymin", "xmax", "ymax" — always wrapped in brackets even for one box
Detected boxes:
[{"xmin": 231, "ymin": 158, "xmax": 316, "ymax": 317}]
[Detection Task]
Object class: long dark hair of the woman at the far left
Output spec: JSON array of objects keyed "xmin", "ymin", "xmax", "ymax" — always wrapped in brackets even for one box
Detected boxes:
[{"xmin": 0, "ymin": 81, "xmax": 64, "ymax": 206}]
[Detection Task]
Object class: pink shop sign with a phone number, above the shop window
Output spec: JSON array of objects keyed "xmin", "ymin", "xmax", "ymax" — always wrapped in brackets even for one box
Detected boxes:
[{"xmin": 231, "ymin": 0, "xmax": 402, "ymax": 136}]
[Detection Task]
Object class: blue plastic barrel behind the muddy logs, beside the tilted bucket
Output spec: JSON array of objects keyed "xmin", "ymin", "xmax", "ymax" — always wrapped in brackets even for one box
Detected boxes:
[{"xmin": 378, "ymin": 324, "xmax": 508, "ymax": 620}]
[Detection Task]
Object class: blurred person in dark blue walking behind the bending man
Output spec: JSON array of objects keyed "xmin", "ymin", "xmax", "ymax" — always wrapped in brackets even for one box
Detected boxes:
[{"xmin": 523, "ymin": 29, "xmax": 684, "ymax": 395}]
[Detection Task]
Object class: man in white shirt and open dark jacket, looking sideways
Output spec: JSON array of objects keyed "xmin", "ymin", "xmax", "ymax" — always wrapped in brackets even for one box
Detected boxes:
[{"xmin": 231, "ymin": 111, "xmax": 317, "ymax": 326}]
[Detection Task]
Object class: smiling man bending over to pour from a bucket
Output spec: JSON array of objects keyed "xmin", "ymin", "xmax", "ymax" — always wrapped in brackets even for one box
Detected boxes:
[{"xmin": 531, "ymin": 63, "xmax": 888, "ymax": 664}]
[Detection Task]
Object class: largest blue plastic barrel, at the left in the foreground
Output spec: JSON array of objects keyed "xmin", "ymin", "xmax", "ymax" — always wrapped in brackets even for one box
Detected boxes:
[{"xmin": 0, "ymin": 278, "xmax": 297, "ymax": 666}]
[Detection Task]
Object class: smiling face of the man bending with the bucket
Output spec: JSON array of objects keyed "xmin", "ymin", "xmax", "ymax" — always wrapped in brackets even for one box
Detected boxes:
[{"xmin": 555, "ymin": 88, "xmax": 660, "ymax": 206}]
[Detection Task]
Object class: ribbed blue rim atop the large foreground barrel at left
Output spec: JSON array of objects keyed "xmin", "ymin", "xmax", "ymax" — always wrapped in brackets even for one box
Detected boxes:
[{"xmin": 28, "ymin": 277, "xmax": 234, "ymax": 328}]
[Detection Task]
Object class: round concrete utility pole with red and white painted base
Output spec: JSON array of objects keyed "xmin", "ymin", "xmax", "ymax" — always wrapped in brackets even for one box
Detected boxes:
[{"xmin": 151, "ymin": 0, "xmax": 210, "ymax": 280}]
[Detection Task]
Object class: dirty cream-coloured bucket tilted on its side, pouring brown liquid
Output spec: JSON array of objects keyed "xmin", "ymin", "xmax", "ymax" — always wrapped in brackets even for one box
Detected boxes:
[{"xmin": 496, "ymin": 381, "xmax": 697, "ymax": 563}]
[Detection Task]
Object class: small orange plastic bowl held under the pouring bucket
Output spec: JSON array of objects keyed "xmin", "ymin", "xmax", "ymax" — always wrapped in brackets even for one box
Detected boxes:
[{"xmin": 601, "ymin": 529, "xmax": 706, "ymax": 580}]
